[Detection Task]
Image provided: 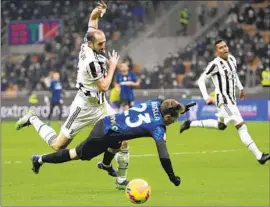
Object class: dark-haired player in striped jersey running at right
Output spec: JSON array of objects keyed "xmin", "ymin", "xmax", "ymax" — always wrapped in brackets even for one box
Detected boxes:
[{"xmin": 180, "ymin": 40, "xmax": 270, "ymax": 164}]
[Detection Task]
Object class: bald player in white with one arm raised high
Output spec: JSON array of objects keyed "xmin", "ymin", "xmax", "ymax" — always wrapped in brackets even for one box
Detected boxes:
[{"xmin": 16, "ymin": 2, "xmax": 129, "ymax": 188}]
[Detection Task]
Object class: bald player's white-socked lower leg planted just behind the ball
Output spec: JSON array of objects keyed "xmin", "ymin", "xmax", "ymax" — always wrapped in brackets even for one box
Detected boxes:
[{"xmin": 115, "ymin": 141, "xmax": 129, "ymax": 190}]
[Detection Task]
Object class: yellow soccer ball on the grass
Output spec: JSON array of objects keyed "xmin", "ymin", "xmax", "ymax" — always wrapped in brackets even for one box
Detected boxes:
[{"xmin": 126, "ymin": 179, "xmax": 151, "ymax": 204}]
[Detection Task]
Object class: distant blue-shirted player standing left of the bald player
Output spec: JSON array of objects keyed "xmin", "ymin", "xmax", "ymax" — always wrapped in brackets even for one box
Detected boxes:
[{"xmin": 48, "ymin": 72, "xmax": 63, "ymax": 125}]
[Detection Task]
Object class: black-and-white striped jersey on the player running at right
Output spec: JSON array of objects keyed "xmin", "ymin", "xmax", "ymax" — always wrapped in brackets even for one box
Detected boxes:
[{"xmin": 200, "ymin": 54, "xmax": 243, "ymax": 105}]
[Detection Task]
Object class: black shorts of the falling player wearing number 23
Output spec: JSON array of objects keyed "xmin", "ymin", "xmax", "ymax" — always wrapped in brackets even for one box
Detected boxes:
[{"xmin": 76, "ymin": 120, "xmax": 121, "ymax": 160}]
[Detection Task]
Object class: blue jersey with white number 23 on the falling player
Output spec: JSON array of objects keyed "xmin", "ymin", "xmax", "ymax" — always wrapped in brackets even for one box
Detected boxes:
[{"xmin": 103, "ymin": 99, "xmax": 166, "ymax": 142}]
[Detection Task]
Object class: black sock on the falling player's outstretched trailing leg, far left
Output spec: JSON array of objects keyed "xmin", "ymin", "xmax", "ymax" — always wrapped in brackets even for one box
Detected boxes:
[{"xmin": 41, "ymin": 149, "xmax": 71, "ymax": 164}]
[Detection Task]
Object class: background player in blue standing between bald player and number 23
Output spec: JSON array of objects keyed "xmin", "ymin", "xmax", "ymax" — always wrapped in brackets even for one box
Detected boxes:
[{"xmin": 116, "ymin": 63, "xmax": 140, "ymax": 110}]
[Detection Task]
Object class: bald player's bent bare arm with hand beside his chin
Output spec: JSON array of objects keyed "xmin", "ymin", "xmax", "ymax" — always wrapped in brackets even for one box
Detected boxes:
[{"xmin": 97, "ymin": 50, "xmax": 120, "ymax": 92}]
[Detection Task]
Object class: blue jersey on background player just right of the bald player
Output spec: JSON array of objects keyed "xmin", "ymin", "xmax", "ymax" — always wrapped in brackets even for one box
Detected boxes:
[{"xmin": 116, "ymin": 72, "xmax": 137, "ymax": 101}]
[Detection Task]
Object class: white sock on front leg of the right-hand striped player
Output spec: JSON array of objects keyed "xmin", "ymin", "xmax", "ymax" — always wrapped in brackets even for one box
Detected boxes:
[{"xmin": 238, "ymin": 124, "xmax": 262, "ymax": 160}]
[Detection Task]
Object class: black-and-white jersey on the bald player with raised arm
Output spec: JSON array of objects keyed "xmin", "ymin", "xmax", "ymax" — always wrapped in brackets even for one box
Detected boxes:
[{"xmin": 76, "ymin": 43, "xmax": 107, "ymax": 104}]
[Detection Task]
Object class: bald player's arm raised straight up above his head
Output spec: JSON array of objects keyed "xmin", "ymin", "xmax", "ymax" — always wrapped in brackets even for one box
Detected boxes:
[{"xmin": 88, "ymin": 1, "xmax": 107, "ymax": 31}]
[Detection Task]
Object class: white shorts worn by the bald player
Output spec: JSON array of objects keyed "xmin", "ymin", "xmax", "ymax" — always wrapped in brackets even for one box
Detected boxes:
[{"xmin": 60, "ymin": 94, "xmax": 116, "ymax": 139}]
